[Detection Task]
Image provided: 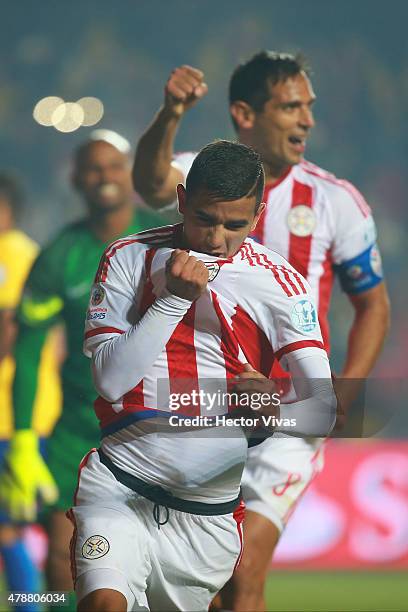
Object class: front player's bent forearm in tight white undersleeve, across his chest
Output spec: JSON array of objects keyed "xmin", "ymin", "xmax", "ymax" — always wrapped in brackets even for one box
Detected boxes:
[{"xmin": 91, "ymin": 294, "xmax": 191, "ymax": 402}]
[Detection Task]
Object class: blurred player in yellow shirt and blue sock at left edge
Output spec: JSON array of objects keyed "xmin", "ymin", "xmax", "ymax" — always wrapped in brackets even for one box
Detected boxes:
[{"xmin": 0, "ymin": 173, "xmax": 63, "ymax": 612}]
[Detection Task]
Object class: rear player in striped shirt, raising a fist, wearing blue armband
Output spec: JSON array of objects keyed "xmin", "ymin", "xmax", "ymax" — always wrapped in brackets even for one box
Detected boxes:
[{"xmin": 133, "ymin": 51, "xmax": 389, "ymax": 611}]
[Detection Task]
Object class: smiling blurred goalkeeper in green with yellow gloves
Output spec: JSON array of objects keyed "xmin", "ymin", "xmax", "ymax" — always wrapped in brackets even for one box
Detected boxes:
[{"xmin": 0, "ymin": 130, "xmax": 161, "ymax": 604}]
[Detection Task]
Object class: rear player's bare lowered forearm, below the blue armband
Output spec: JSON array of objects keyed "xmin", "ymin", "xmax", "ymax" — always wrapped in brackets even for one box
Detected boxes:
[{"xmin": 341, "ymin": 292, "xmax": 390, "ymax": 378}]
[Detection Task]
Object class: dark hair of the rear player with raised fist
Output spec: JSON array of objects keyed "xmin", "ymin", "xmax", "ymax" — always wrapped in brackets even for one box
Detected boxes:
[{"xmin": 229, "ymin": 51, "xmax": 310, "ymax": 128}]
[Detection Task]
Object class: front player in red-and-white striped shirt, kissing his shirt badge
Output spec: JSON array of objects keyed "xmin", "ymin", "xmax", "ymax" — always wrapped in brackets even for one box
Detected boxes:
[{"xmin": 69, "ymin": 141, "xmax": 336, "ymax": 612}]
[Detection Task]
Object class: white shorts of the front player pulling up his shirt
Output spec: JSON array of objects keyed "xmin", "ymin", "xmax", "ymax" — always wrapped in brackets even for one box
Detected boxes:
[{"xmin": 68, "ymin": 450, "xmax": 243, "ymax": 612}]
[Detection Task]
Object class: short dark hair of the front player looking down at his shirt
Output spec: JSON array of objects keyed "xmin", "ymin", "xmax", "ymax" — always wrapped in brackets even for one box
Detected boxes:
[{"xmin": 186, "ymin": 140, "xmax": 265, "ymax": 212}]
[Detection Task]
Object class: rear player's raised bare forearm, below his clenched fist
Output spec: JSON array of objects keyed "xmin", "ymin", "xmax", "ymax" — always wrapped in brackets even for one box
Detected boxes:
[{"xmin": 132, "ymin": 107, "xmax": 181, "ymax": 208}]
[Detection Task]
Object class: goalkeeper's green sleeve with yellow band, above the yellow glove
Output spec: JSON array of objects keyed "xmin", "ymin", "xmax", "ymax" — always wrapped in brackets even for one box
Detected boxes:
[{"xmin": 13, "ymin": 241, "xmax": 63, "ymax": 429}]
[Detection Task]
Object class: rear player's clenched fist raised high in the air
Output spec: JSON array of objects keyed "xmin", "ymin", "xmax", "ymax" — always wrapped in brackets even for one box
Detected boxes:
[{"xmin": 164, "ymin": 66, "xmax": 208, "ymax": 117}]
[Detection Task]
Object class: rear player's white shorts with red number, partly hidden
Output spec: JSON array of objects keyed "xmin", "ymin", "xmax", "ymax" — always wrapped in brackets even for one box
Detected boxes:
[{"xmin": 242, "ymin": 437, "xmax": 324, "ymax": 531}]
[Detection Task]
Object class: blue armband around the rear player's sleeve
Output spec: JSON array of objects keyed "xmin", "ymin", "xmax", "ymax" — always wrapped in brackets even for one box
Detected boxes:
[{"xmin": 334, "ymin": 243, "xmax": 383, "ymax": 293}]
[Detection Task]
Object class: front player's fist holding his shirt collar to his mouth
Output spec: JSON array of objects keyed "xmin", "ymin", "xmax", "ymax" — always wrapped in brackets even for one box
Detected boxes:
[{"xmin": 166, "ymin": 249, "xmax": 208, "ymax": 301}]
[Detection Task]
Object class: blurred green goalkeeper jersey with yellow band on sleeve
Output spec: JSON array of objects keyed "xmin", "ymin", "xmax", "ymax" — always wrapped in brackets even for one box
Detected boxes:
[{"xmin": 13, "ymin": 209, "xmax": 160, "ymax": 435}]
